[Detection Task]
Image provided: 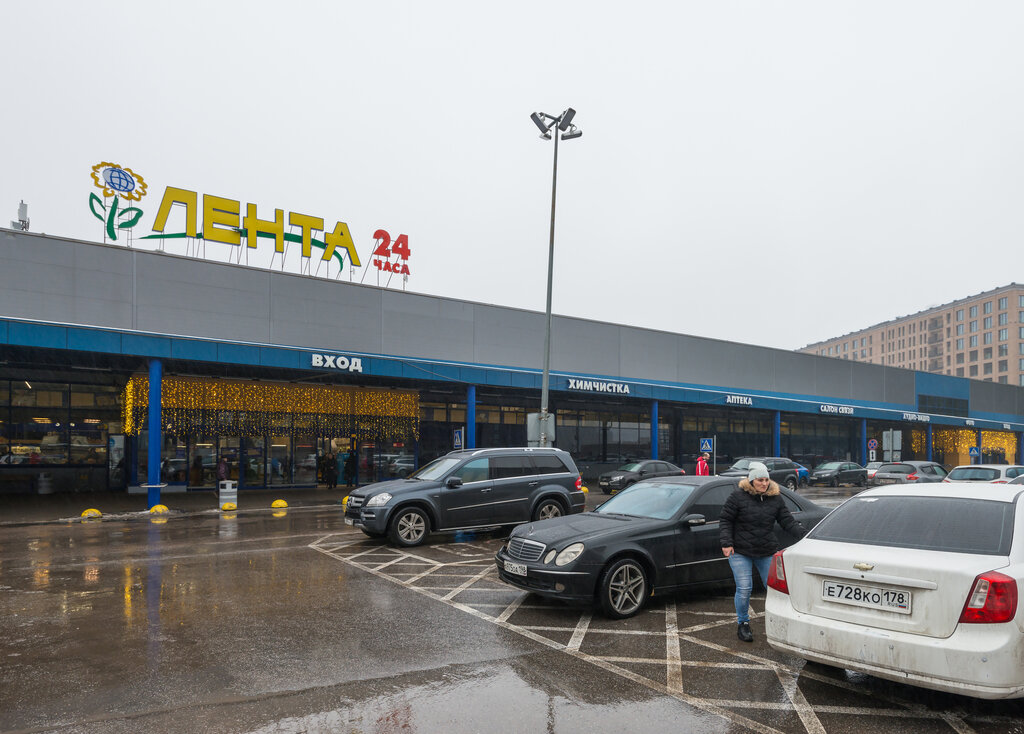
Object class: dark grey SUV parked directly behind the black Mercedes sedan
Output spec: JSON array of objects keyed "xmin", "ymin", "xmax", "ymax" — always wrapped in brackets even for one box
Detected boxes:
[{"xmin": 345, "ymin": 448, "xmax": 586, "ymax": 546}]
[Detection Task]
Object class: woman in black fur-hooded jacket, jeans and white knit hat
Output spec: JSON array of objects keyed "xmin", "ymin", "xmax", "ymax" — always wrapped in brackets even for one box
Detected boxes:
[{"xmin": 719, "ymin": 462, "xmax": 807, "ymax": 642}]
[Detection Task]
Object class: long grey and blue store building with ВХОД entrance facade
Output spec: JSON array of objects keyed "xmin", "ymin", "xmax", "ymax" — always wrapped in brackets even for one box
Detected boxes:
[{"xmin": 6, "ymin": 230, "xmax": 1024, "ymax": 503}]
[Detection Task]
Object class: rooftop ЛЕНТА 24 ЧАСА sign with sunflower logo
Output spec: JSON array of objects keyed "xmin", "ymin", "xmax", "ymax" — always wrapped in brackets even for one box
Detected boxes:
[{"xmin": 89, "ymin": 162, "xmax": 411, "ymax": 276}]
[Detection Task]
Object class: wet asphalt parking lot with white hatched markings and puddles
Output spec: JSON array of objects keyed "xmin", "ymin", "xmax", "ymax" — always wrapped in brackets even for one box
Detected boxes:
[{"xmin": 0, "ymin": 489, "xmax": 1024, "ymax": 734}]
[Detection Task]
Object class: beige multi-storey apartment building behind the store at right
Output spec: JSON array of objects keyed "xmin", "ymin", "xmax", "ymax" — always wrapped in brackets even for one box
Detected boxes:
[{"xmin": 799, "ymin": 283, "xmax": 1024, "ymax": 385}]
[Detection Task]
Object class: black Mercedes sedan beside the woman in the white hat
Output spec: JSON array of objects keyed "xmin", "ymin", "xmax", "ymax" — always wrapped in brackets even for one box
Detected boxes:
[{"xmin": 495, "ymin": 476, "xmax": 828, "ymax": 619}]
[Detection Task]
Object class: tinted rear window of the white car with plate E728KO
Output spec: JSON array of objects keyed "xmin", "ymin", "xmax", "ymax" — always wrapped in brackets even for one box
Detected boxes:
[{"xmin": 809, "ymin": 495, "xmax": 1015, "ymax": 556}]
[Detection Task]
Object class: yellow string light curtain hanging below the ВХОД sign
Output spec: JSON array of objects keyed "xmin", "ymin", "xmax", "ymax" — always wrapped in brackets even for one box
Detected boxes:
[{"xmin": 122, "ymin": 375, "xmax": 420, "ymax": 440}]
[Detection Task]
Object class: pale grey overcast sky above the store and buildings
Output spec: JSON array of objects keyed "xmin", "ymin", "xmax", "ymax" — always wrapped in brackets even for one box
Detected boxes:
[{"xmin": 0, "ymin": 0, "xmax": 1024, "ymax": 349}]
